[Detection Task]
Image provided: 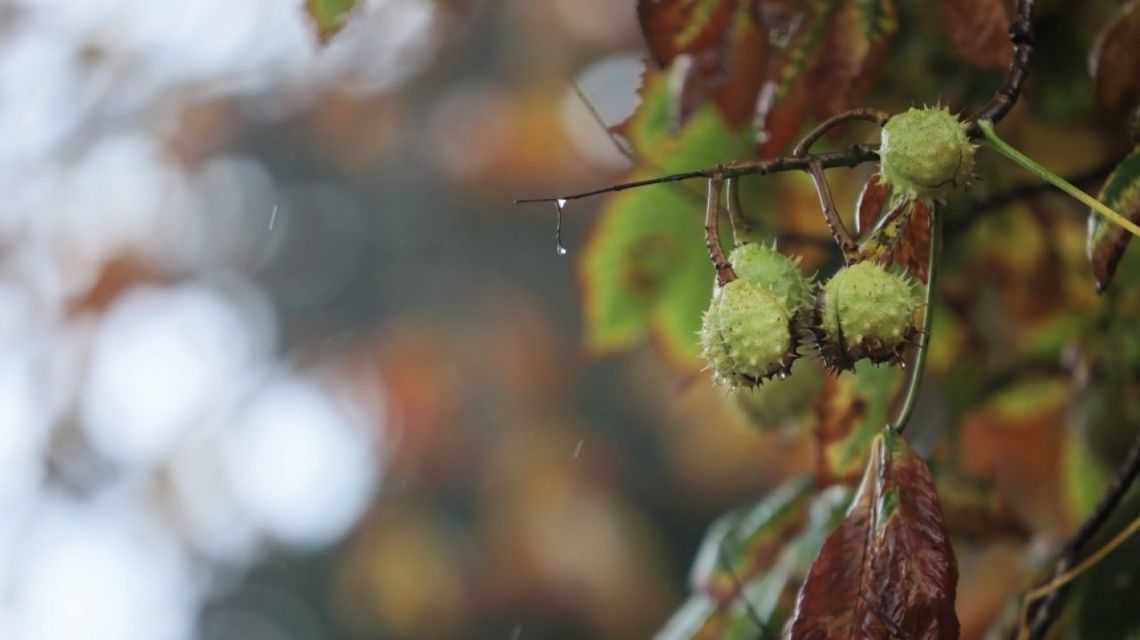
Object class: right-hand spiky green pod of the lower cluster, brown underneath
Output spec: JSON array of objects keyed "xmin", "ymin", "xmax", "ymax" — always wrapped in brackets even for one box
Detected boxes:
[{"xmin": 813, "ymin": 261, "xmax": 920, "ymax": 370}]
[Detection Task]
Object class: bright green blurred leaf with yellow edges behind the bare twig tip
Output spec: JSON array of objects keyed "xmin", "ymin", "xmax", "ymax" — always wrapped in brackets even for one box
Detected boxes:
[{"xmin": 578, "ymin": 72, "xmax": 751, "ymax": 366}]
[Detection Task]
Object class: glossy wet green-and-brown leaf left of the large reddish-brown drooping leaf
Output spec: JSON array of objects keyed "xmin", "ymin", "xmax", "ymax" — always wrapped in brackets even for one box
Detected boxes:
[{"xmin": 656, "ymin": 480, "xmax": 852, "ymax": 640}]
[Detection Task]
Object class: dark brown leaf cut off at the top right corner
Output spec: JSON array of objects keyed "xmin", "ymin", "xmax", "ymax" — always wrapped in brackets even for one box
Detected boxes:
[{"xmin": 1089, "ymin": 0, "xmax": 1140, "ymax": 108}]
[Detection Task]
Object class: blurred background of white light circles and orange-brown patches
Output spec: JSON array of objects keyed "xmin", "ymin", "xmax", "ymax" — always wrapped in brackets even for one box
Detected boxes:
[{"xmin": 0, "ymin": 0, "xmax": 809, "ymax": 640}]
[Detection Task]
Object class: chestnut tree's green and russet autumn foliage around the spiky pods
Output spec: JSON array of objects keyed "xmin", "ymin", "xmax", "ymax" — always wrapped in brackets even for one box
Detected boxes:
[{"xmin": 319, "ymin": 0, "xmax": 1140, "ymax": 640}]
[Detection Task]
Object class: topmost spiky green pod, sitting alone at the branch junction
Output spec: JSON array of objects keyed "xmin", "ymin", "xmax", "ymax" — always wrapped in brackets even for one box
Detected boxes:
[{"xmin": 879, "ymin": 107, "xmax": 977, "ymax": 200}]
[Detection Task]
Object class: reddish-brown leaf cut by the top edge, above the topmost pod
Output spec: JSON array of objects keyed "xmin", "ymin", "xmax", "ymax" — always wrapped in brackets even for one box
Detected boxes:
[{"xmin": 942, "ymin": 0, "xmax": 1013, "ymax": 68}]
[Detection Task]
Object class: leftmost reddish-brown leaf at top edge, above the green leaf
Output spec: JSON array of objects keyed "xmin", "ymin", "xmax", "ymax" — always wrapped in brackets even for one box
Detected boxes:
[{"xmin": 637, "ymin": 0, "xmax": 768, "ymax": 128}]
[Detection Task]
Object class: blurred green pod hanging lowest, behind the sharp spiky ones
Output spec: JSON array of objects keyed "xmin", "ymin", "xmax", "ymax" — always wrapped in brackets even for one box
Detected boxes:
[{"xmin": 728, "ymin": 363, "xmax": 823, "ymax": 431}]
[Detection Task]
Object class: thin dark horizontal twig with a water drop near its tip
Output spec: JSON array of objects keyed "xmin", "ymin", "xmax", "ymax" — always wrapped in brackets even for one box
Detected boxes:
[{"xmin": 514, "ymin": 145, "xmax": 879, "ymax": 204}]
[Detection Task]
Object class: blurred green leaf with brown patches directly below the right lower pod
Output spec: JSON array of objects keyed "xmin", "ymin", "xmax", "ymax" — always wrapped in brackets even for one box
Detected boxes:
[{"xmin": 816, "ymin": 360, "xmax": 903, "ymax": 485}]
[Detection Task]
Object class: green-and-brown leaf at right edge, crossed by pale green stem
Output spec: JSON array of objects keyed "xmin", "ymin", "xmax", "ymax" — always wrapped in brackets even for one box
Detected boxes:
[{"xmin": 1086, "ymin": 146, "xmax": 1140, "ymax": 291}]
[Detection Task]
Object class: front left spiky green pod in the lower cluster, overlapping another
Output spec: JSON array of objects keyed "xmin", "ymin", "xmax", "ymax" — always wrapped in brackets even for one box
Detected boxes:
[{"xmin": 701, "ymin": 278, "xmax": 798, "ymax": 388}]
